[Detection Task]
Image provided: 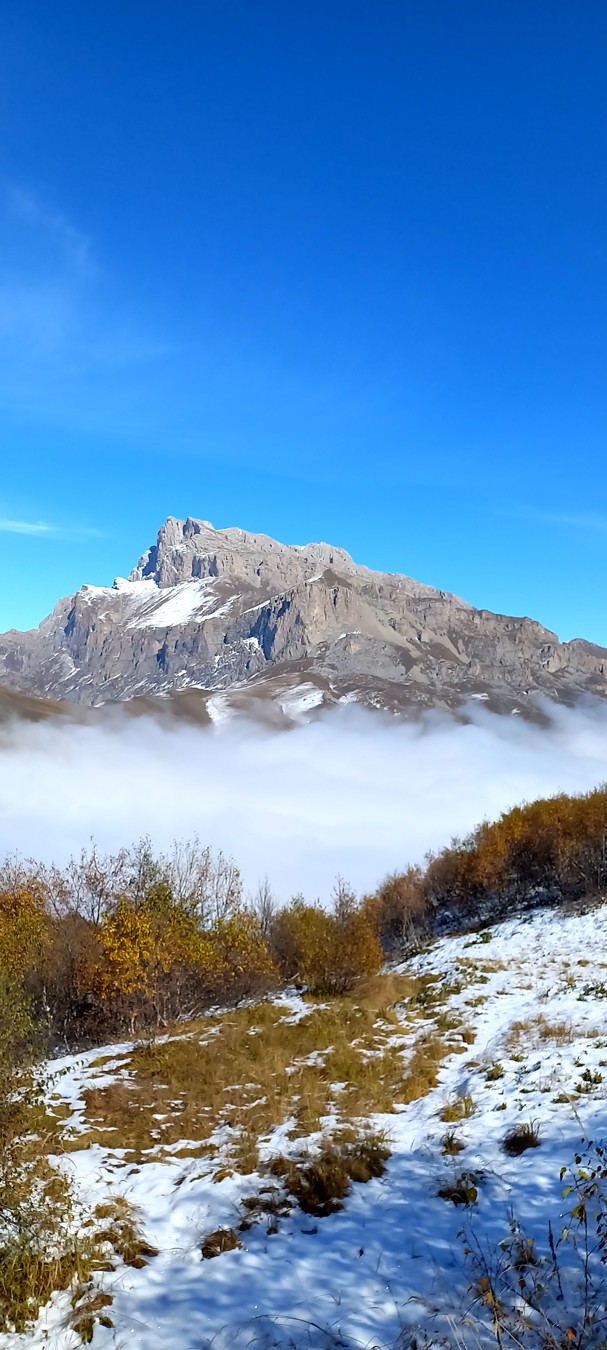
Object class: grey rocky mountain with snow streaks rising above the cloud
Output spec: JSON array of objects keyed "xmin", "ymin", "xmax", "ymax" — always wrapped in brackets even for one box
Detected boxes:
[{"xmin": 0, "ymin": 517, "xmax": 607, "ymax": 718}]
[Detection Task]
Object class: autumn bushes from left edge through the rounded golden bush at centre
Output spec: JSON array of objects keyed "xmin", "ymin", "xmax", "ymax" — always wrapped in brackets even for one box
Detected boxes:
[{"xmin": 0, "ymin": 840, "xmax": 383, "ymax": 1062}]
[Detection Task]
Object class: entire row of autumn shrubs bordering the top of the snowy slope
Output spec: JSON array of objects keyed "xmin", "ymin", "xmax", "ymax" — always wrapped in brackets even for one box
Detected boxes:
[{"xmin": 0, "ymin": 787, "xmax": 607, "ymax": 1060}]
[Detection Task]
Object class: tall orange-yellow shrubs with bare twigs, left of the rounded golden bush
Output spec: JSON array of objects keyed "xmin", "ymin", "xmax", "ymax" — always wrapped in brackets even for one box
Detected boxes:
[{"xmin": 0, "ymin": 840, "xmax": 278, "ymax": 1048}]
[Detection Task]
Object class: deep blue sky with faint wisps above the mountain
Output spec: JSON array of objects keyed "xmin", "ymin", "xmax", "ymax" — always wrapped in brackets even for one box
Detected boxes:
[{"xmin": 0, "ymin": 0, "xmax": 607, "ymax": 645}]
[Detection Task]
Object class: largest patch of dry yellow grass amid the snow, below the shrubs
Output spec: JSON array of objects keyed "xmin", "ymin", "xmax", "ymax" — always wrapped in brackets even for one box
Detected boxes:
[{"xmin": 58, "ymin": 975, "xmax": 469, "ymax": 1172}]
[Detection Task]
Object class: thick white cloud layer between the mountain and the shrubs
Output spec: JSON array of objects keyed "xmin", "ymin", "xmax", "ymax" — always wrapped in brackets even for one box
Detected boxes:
[{"xmin": 0, "ymin": 702, "xmax": 607, "ymax": 898}]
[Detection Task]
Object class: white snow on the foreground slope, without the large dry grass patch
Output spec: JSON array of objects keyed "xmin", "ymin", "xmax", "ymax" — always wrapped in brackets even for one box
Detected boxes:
[{"xmin": 9, "ymin": 907, "xmax": 607, "ymax": 1350}]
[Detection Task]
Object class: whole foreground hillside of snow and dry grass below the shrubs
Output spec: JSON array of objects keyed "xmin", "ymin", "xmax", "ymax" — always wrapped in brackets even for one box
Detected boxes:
[{"xmin": 13, "ymin": 907, "xmax": 607, "ymax": 1350}]
